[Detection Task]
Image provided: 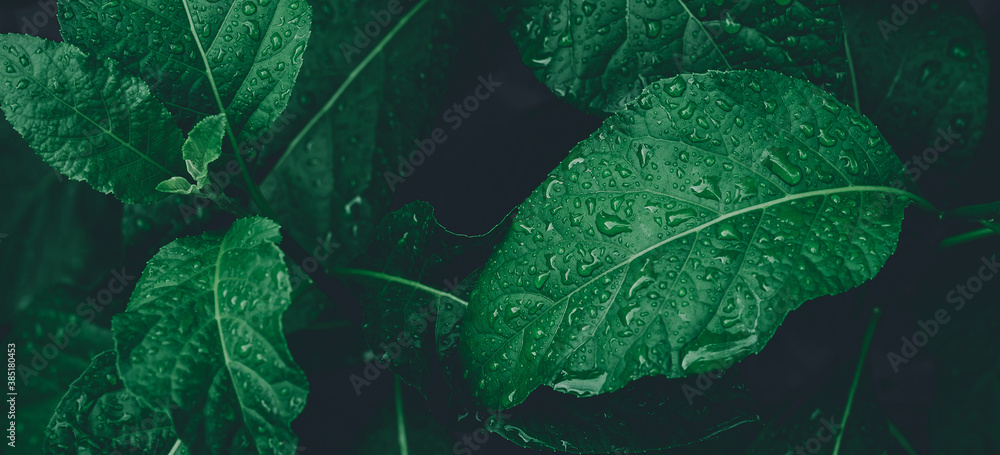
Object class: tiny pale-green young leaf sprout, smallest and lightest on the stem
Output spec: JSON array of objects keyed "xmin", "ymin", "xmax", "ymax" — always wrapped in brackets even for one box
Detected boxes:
[{"xmin": 156, "ymin": 114, "xmax": 226, "ymax": 194}]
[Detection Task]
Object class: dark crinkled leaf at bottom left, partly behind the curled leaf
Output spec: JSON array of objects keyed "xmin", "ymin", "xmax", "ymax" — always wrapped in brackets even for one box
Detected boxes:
[{"xmin": 45, "ymin": 351, "xmax": 188, "ymax": 455}]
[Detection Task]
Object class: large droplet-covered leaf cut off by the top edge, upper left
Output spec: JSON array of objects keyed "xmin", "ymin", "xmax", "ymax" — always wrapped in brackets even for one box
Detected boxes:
[{"xmin": 59, "ymin": 0, "xmax": 312, "ymax": 141}]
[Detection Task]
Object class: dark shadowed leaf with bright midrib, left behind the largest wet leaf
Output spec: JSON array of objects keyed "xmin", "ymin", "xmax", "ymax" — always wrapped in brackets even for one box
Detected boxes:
[{"xmin": 350, "ymin": 201, "xmax": 506, "ymax": 394}]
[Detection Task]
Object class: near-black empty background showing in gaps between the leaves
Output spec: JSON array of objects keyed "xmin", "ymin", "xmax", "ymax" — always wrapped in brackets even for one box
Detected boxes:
[{"xmin": 0, "ymin": 0, "xmax": 1000, "ymax": 455}]
